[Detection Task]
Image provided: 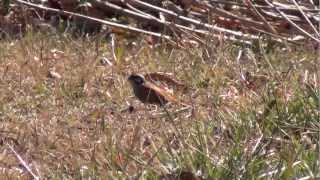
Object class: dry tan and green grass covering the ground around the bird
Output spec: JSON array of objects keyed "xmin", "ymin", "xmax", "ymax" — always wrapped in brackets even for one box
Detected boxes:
[{"xmin": 0, "ymin": 32, "xmax": 320, "ymax": 179}]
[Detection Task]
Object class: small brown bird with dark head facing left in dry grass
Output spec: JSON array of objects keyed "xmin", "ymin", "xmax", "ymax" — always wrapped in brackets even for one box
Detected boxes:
[{"xmin": 128, "ymin": 74, "xmax": 177, "ymax": 106}]
